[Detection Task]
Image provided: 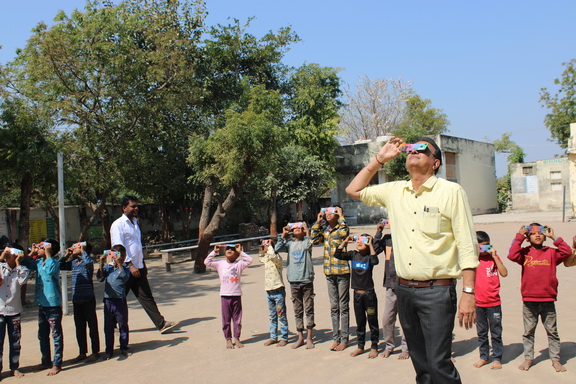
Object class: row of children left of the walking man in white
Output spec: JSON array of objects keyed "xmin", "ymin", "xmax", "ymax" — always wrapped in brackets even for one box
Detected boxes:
[{"xmin": 0, "ymin": 239, "xmax": 130, "ymax": 380}]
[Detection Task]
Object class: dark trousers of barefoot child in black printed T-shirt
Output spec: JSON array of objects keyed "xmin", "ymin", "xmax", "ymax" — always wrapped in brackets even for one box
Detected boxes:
[{"xmin": 354, "ymin": 291, "xmax": 380, "ymax": 349}]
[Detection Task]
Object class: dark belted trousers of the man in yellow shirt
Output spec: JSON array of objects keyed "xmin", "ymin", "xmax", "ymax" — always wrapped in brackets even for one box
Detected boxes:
[{"xmin": 395, "ymin": 284, "xmax": 461, "ymax": 384}]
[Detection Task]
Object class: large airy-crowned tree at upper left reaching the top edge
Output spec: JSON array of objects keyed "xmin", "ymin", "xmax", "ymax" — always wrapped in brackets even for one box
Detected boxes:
[{"xmin": 3, "ymin": 0, "xmax": 205, "ymax": 244}]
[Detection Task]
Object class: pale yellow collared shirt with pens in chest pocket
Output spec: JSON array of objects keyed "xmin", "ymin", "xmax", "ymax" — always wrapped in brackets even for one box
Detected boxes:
[{"xmin": 360, "ymin": 176, "xmax": 479, "ymax": 280}]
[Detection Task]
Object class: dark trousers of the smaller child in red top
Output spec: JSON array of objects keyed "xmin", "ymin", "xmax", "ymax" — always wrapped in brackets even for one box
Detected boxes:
[{"xmin": 476, "ymin": 305, "xmax": 504, "ymax": 361}]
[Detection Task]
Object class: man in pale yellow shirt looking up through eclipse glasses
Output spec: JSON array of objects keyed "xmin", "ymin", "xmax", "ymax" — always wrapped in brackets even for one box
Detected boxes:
[{"xmin": 346, "ymin": 137, "xmax": 478, "ymax": 384}]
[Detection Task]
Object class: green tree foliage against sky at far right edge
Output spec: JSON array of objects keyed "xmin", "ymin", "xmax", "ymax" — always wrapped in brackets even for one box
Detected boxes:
[{"xmin": 540, "ymin": 59, "xmax": 576, "ymax": 148}]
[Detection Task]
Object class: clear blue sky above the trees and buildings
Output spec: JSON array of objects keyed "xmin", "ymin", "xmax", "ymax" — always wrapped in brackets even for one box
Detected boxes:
[{"xmin": 0, "ymin": 0, "xmax": 576, "ymax": 176}]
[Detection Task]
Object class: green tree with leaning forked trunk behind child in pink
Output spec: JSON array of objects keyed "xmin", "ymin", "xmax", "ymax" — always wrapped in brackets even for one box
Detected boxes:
[{"xmin": 188, "ymin": 85, "xmax": 285, "ymax": 272}]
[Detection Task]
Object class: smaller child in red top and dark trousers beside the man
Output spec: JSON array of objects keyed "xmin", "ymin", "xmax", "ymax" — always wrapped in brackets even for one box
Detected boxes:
[{"xmin": 474, "ymin": 231, "xmax": 508, "ymax": 369}]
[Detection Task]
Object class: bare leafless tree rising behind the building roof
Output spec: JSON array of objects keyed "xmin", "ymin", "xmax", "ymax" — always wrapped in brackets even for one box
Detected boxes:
[{"xmin": 340, "ymin": 75, "xmax": 412, "ymax": 143}]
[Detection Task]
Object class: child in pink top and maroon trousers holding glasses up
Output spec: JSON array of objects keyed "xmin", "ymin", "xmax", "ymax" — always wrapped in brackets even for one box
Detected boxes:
[{"xmin": 204, "ymin": 244, "xmax": 252, "ymax": 349}]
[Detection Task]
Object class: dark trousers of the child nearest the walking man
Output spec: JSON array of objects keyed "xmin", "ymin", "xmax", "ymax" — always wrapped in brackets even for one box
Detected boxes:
[{"xmin": 104, "ymin": 298, "xmax": 129, "ymax": 355}]
